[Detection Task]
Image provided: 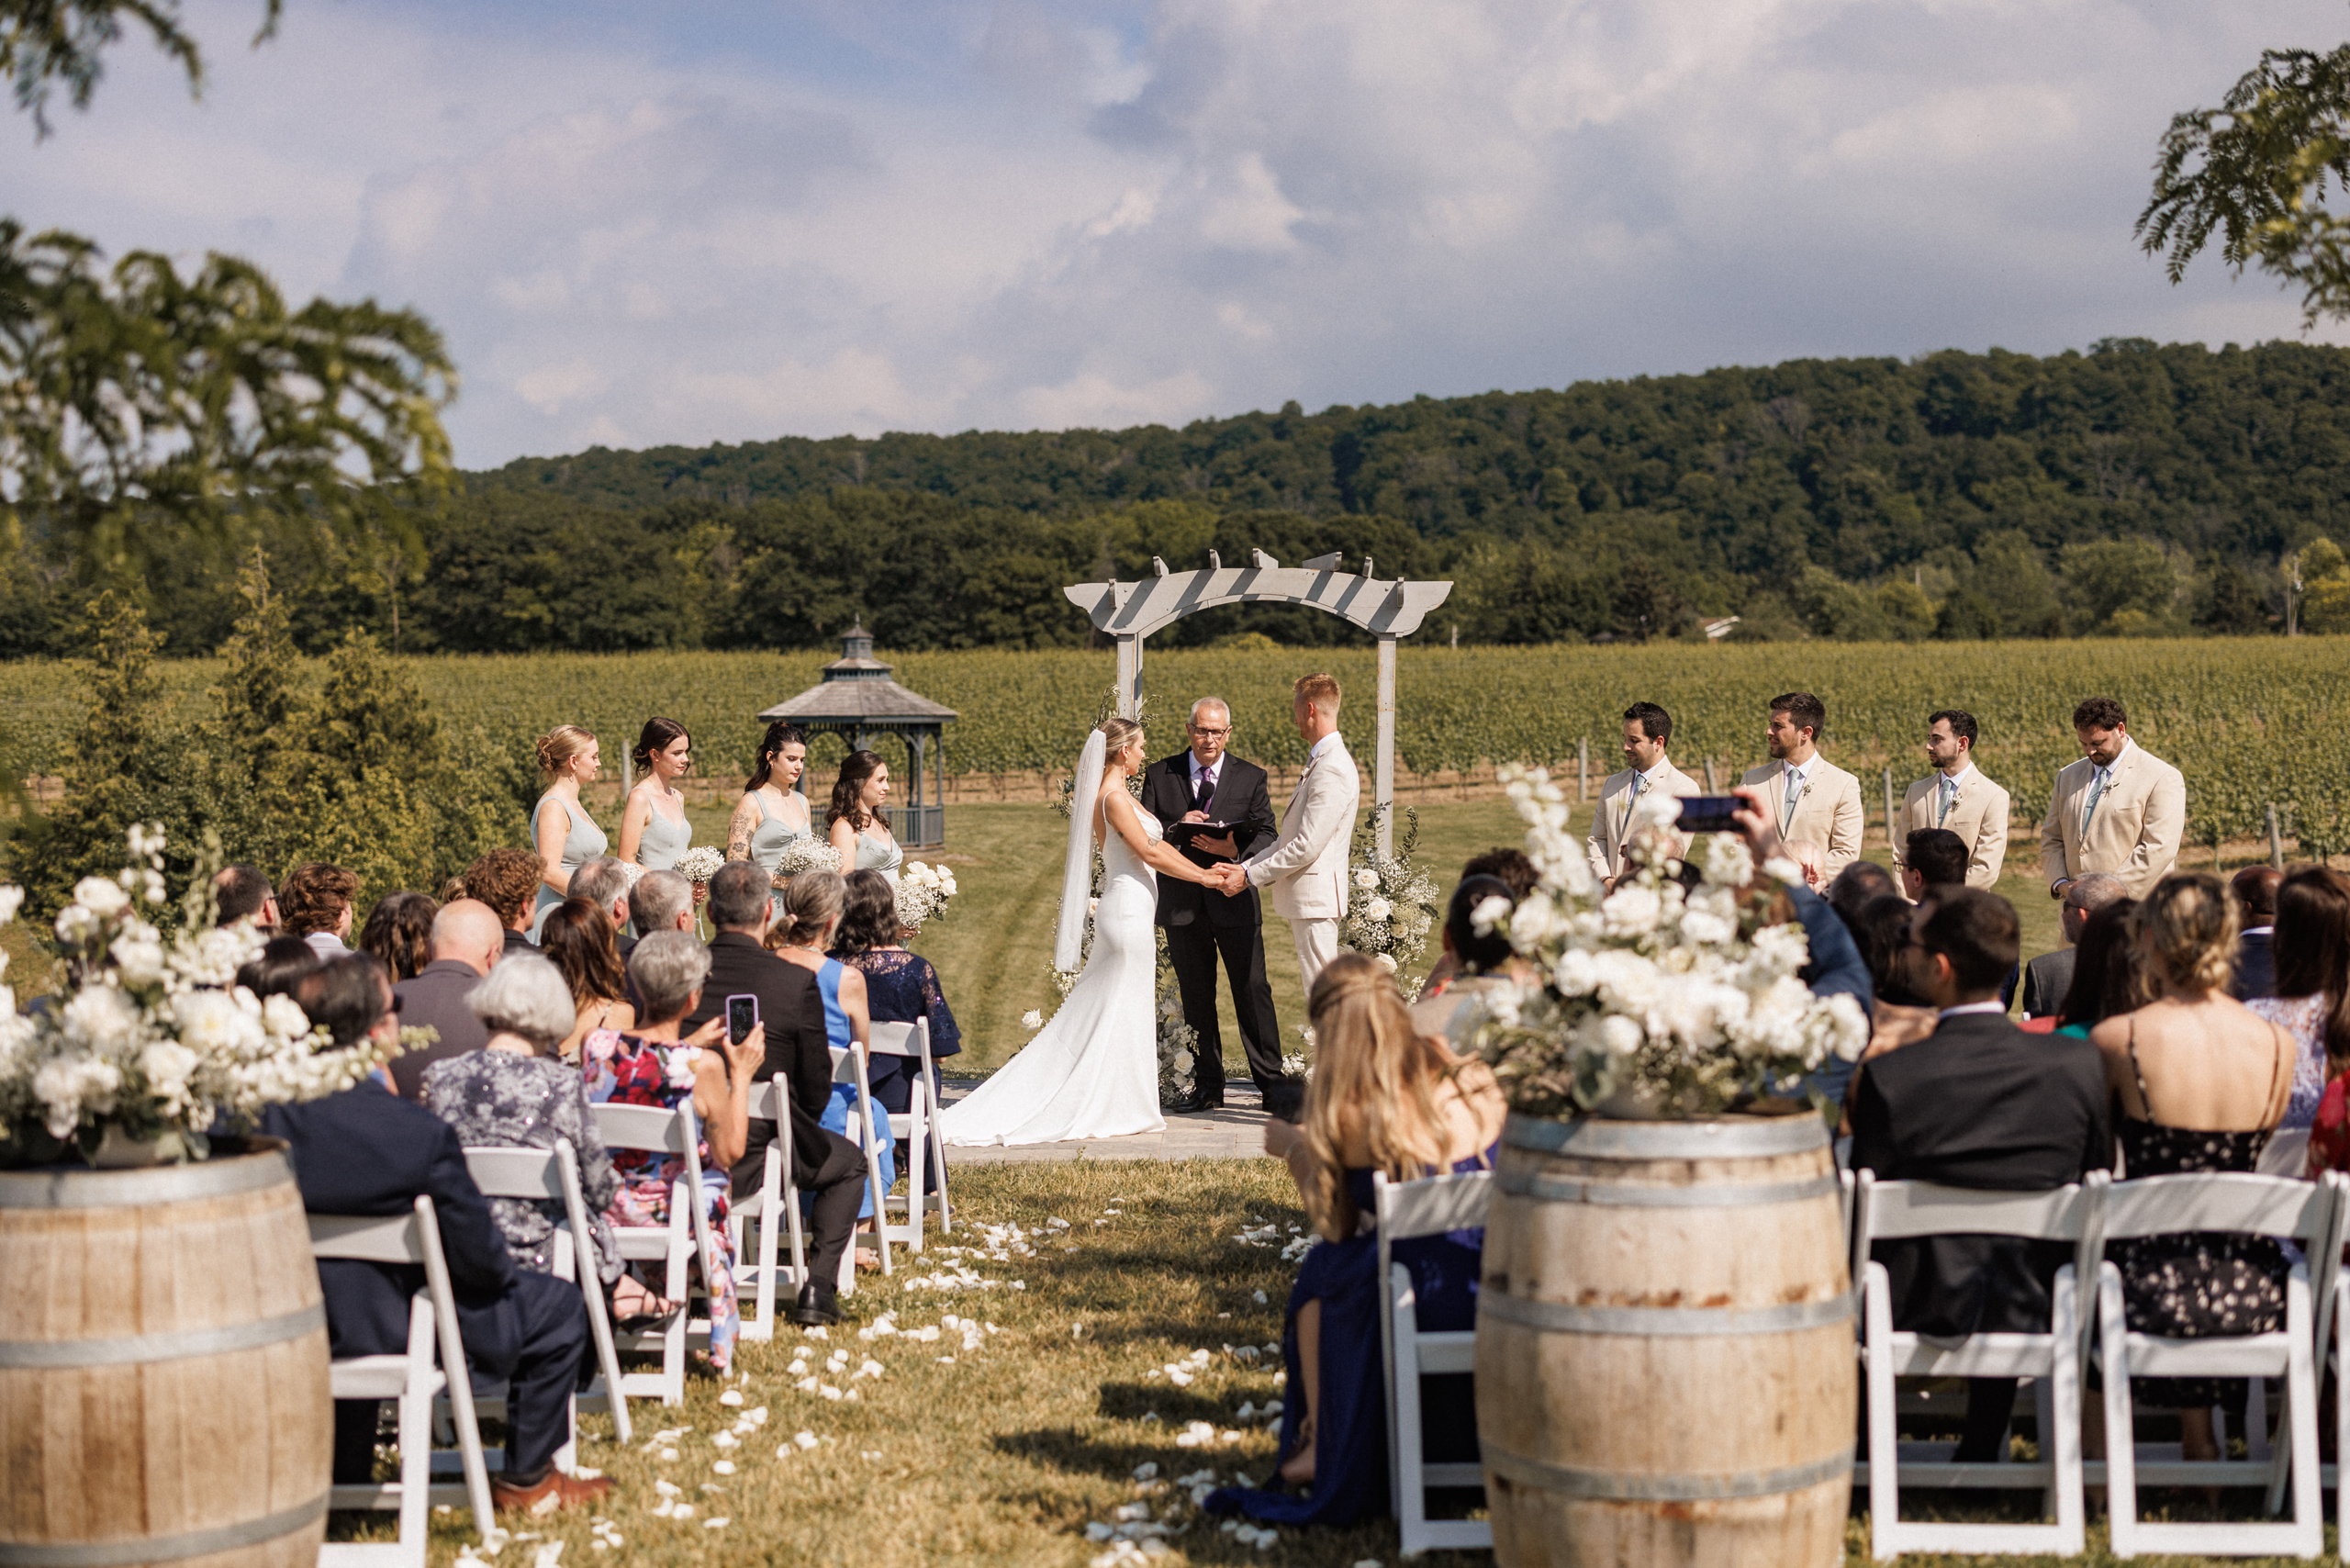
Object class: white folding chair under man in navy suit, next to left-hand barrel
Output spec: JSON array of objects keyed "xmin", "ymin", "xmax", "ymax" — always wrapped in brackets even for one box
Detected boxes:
[{"xmin": 310, "ymin": 1196, "xmax": 494, "ymax": 1568}]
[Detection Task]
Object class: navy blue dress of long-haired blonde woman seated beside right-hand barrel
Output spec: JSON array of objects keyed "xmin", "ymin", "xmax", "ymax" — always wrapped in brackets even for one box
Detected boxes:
[{"xmin": 1203, "ymin": 1143, "xmax": 1502, "ymax": 1526}]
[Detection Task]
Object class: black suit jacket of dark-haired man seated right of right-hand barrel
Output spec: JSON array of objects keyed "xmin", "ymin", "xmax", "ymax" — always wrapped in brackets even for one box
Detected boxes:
[{"xmin": 1852, "ymin": 1014, "xmax": 2112, "ymax": 1338}]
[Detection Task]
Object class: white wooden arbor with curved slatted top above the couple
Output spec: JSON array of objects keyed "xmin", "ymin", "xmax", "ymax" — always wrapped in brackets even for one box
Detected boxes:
[{"xmin": 1062, "ymin": 550, "xmax": 1452, "ymax": 856}]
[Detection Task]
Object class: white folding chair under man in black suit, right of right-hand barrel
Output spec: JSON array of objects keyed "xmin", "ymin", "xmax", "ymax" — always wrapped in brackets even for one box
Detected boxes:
[{"xmin": 1852, "ymin": 1170, "xmax": 2110, "ymax": 1561}]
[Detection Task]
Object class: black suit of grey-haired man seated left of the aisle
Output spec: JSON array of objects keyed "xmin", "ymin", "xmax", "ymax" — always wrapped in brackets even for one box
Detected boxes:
[{"xmin": 679, "ymin": 931, "xmax": 865, "ymax": 1282}]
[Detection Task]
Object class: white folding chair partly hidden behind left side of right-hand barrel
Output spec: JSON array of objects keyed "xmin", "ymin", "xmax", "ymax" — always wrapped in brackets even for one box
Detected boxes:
[{"xmin": 1372, "ymin": 1170, "xmax": 1493, "ymax": 1556}]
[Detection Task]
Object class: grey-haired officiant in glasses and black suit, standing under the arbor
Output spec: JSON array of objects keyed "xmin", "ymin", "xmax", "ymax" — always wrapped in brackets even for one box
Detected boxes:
[{"xmin": 1142, "ymin": 696, "xmax": 1304, "ymax": 1121}]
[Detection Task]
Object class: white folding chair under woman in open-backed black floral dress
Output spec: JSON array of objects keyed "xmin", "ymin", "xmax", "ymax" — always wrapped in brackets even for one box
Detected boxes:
[{"xmin": 2089, "ymin": 1170, "xmax": 2341, "ymax": 1556}]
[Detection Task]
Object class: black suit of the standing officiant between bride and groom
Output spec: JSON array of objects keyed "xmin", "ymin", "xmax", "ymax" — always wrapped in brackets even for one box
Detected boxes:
[{"xmin": 1142, "ymin": 750, "xmax": 1304, "ymax": 1116}]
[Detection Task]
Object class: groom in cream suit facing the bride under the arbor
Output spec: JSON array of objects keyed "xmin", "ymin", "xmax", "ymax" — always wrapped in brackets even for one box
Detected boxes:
[{"xmin": 1222, "ymin": 675, "xmax": 1363, "ymax": 997}]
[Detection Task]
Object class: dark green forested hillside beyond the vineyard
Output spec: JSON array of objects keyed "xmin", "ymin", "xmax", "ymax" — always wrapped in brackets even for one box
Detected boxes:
[{"xmin": 0, "ymin": 341, "xmax": 2350, "ymax": 654}]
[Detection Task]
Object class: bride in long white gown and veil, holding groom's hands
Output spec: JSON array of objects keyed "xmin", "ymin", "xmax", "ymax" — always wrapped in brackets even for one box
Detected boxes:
[{"xmin": 937, "ymin": 720, "xmax": 1215, "ymax": 1145}]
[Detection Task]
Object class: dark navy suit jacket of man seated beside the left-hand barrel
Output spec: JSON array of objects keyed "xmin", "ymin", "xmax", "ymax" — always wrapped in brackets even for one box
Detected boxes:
[{"xmin": 261, "ymin": 1079, "xmax": 529, "ymax": 1378}]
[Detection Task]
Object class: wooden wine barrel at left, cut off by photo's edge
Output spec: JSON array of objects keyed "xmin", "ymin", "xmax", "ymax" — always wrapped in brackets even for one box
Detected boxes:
[{"xmin": 0, "ymin": 1140, "xmax": 334, "ymax": 1568}]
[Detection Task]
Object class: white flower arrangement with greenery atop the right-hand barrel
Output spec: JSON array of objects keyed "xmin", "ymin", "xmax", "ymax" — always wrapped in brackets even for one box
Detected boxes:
[{"xmin": 1478, "ymin": 767, "xmax": 1868, "ymax": 1119}]
